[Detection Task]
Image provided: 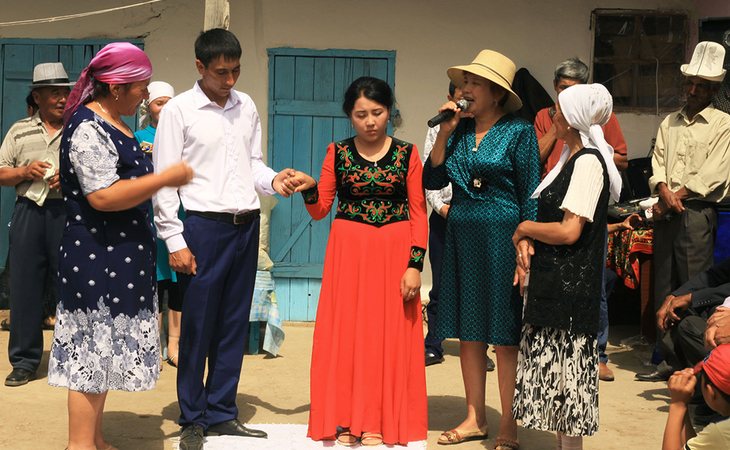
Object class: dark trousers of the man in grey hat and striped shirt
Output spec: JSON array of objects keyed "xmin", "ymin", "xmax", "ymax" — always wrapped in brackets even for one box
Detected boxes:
[{"xmin": 8, "ymin": 198, "xmax": 66, "ymax": 372}]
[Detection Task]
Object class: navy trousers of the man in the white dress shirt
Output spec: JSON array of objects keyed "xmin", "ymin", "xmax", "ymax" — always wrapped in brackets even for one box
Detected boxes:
[{"xmin": 177, "ymin": 215, "xmax": 259, "ymax": 428}]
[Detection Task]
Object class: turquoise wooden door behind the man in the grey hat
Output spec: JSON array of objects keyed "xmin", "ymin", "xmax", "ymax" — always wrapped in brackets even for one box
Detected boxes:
[{"xmin": 0, "ymin": 39, "xmax": 142, "ymax": 270}]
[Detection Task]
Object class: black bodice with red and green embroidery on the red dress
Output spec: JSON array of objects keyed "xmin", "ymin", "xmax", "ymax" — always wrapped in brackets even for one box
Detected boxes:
[{"xmin": 334, "ymin": 138, "xmax": 413, "ymax": 226}]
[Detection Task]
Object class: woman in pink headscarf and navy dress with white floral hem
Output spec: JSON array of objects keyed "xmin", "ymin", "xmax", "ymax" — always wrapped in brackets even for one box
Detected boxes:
[{"xmin": 48, "ymin": 43, "xmax": 192, "ymax": 450}]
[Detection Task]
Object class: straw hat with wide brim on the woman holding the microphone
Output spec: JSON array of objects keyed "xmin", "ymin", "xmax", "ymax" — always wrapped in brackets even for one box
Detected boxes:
[{"xmin": 446, "ymin": 50, "xmax": 522, "ymax": 112}]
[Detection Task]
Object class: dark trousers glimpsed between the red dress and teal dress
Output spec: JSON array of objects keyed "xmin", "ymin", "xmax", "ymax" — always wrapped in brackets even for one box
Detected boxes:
[{"xmin": 425, "ymin": 211, "xmax": 446, "ymax": 356}]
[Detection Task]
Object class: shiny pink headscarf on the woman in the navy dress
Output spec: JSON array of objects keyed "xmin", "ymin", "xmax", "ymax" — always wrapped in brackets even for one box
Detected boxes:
[{"xmin": 63, "ymin": 42, "xmax": 152, "ymax": 123}]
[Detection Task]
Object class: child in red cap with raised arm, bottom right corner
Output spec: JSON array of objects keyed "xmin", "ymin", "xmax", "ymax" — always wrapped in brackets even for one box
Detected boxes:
[{"xmin": 662, "ymin": 344, "xmax": 730, "ymax": 450}]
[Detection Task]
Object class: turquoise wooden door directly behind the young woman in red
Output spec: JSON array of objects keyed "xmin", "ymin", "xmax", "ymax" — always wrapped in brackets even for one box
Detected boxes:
[{"xmin": 268, "ymin": 48, "xmax": 395, "ymax": 321}]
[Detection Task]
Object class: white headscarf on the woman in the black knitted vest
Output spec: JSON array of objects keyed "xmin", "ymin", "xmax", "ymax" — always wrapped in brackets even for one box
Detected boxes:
[{"xmin": 532, "ymin": 84, "xmax": 621, "ymax": 201}]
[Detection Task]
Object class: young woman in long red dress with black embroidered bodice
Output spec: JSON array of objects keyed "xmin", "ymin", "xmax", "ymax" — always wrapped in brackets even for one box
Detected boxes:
[{"xmin": 298, "ymin": 77, "xmax": 428, "ymax": 445}]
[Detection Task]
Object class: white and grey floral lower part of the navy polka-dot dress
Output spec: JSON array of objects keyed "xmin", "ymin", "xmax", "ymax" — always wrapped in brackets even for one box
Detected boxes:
[{"xmin": 48, "ymin": 297, "xmax": 160, "ymax": 393}]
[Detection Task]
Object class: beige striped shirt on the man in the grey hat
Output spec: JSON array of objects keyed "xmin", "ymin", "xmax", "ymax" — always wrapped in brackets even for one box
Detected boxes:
[{"xmin": 0, "ymin": 113, "xmax": 63, "ymax": 199}]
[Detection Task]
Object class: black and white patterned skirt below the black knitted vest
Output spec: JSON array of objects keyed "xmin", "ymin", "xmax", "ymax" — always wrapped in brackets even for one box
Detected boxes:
[{"xmin": 512, "ymin": 324, "xmax": 598, "ymax": 436}]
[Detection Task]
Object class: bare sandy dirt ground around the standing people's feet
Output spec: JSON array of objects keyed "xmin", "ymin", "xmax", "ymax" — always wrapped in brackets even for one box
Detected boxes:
[{"xmin": 0, "ymin": 311, "xmax": 668, "ymax": 450}]
